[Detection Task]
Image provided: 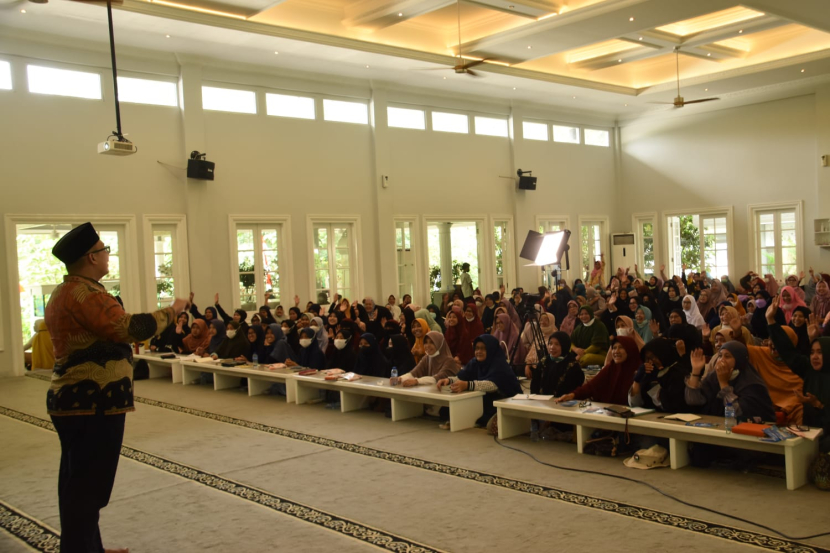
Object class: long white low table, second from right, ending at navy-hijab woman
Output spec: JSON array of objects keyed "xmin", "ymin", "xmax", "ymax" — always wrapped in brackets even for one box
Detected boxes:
[{"xmin": 294, "ymin": 372, "xmax": 484, "ymax": 432}]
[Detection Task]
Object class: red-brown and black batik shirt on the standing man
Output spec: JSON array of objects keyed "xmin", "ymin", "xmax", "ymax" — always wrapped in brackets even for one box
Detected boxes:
[{"xmin": 46, "ymin": 276, "xmax": 176, "ymax": 415}]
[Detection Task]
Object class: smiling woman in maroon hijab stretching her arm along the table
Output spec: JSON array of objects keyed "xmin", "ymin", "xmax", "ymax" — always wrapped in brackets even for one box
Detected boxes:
[{"xmin": 556, "ymin": 336, "xmax": 640, "ymax": 405}]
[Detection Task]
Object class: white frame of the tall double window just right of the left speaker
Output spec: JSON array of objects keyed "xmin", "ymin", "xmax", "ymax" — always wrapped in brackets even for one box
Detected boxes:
[{"xmin": 225, "ymin": 214, "xmax": 294, "ymax": 311}]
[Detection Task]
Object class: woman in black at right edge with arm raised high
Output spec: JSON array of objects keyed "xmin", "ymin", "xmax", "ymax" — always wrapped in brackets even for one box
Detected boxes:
[{"xmin": 767, "ymin": 301, "xmax": 830, "ymax": 453}]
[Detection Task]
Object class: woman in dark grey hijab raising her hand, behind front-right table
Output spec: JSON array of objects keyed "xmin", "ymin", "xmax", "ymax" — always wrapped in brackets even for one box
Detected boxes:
[{"xmin": 686, "ymin": 338, "xmax": 776, "ymax": 421}]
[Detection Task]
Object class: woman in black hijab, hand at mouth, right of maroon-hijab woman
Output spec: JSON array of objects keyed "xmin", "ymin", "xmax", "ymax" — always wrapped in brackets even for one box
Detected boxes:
[{"xmin": 628, "ymin": 338, "xmax": 695, "ymax": 413}]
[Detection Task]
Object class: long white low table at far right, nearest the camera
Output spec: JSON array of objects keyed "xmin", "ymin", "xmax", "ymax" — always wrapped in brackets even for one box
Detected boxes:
[{"xmin": 494, "ymin": 399, "xmax": 818, "ymax": 490}]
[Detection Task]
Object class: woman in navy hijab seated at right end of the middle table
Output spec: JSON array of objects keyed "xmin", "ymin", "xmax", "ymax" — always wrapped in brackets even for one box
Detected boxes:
[{"xmin": 436, "ymin": 334, "xmax": 522, "ymax": 435}]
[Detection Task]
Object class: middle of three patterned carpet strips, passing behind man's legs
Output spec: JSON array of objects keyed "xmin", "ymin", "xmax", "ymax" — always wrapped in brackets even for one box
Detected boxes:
[{"xmin": 0, "ymin": 406, "xmax": 443, "ymax": 553}]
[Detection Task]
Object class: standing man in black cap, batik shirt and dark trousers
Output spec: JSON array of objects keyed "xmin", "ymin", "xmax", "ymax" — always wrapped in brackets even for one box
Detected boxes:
[{"xmin": 46, "ymin": 223, "xmax": 188, "ymax": 553}]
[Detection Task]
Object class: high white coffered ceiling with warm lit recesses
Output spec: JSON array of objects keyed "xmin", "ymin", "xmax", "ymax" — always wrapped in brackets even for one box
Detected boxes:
[{"xmin": 0, "ymin": 0, "xmax": 830, "ymax": 119}]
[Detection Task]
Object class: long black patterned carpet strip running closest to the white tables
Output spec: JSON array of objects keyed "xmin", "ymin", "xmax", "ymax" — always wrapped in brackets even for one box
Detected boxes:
[{"xmin": 19, "ymin": 373, "xmax": 830, "ymax": 553}]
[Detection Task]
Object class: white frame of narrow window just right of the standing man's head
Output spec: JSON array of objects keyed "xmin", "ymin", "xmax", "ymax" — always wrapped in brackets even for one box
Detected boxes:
[{"xmin": 143, "ymin": 214, "xmax": 191, "ymax": 312}]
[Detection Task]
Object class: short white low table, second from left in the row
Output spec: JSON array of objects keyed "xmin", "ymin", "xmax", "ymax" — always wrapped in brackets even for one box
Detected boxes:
[{"xmin": 181, "ymin": 361, "xmax": 296, "ymax": 403}]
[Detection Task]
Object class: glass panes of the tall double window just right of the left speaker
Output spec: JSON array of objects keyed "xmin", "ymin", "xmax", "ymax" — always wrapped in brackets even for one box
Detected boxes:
[{"xmin": 236, "ymin": 224, "xmax": 282, "ymax": 311}]
